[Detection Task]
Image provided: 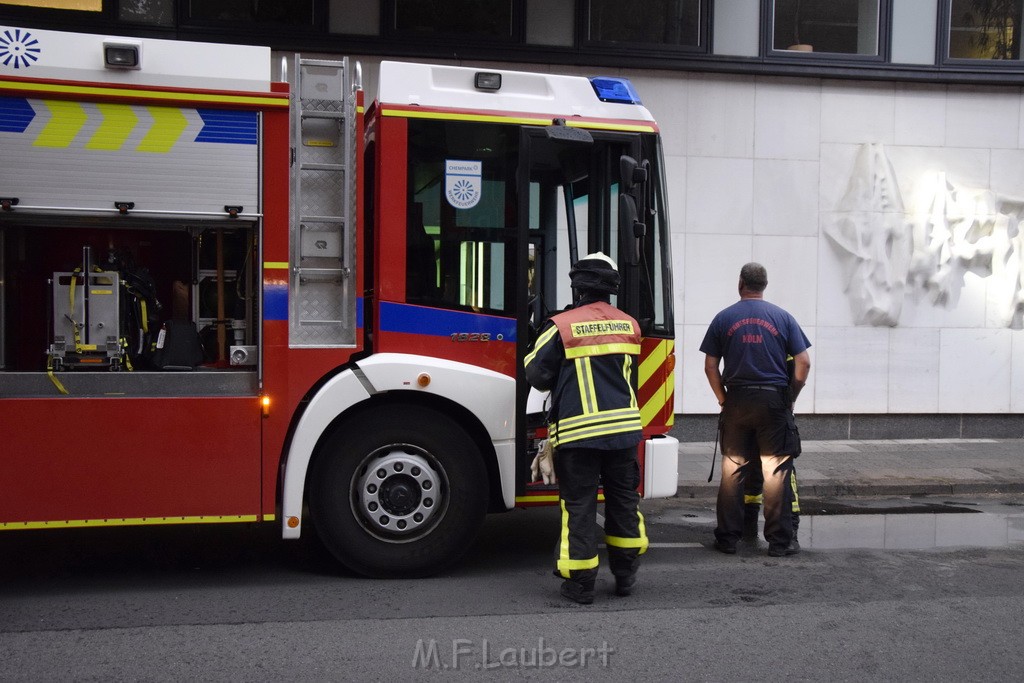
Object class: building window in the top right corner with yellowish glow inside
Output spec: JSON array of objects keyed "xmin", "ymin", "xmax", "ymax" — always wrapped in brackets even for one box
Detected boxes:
[{"xmin": 949, "ymin": 0, "xmax": 1024, "ymax": 59}]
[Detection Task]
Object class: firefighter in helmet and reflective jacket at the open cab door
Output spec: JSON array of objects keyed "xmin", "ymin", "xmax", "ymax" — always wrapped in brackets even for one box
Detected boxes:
[{"xmin": 525, "ymin": 252, "xmax": 647, "ymax": 604}]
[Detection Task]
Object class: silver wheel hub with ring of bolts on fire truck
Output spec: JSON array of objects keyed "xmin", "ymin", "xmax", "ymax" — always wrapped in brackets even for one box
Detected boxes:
[{"xmin": 356, "ymin": 445, "xmax": 444, "ymax": 537}]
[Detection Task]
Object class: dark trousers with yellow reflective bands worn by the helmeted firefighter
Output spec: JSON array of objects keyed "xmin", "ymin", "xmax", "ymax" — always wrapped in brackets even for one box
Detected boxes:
[{"xmin": 555, "ymin": 446, "xmax": 647, "ymax": 585}]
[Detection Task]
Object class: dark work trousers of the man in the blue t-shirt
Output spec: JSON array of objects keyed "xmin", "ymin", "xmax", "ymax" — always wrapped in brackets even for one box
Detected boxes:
[{"xmin": 715, "ymin": 387, "xmax": 794, "ymax": 550}]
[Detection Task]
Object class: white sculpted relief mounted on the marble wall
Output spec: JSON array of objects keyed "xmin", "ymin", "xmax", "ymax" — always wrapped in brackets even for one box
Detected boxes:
[{"xmin": 825, "ymin": 143, "xmax": 1024, "ymax": 329}]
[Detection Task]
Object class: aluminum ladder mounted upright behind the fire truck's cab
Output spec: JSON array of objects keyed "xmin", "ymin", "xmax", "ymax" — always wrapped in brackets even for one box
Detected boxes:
[{"xmin": 288, "ymin": 55, "xmax": 360, "ymax": 347}]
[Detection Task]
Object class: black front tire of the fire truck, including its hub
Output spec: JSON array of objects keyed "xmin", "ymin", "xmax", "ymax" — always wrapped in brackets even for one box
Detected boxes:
[{"xmin": 309, "ymin": 405, "xmax": 488, "ymax": 578}]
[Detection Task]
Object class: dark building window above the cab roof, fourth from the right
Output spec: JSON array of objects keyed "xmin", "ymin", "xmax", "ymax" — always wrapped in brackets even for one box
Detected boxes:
[{"xmin": 389, "ymin": 0, "xmax": 521, "ymax": 40}]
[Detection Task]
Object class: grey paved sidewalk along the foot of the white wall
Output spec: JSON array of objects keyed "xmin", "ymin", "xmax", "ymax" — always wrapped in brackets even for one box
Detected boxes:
[{"xmin": 677, "ymin": 438, "xmax": 1024, "ymax": 498}]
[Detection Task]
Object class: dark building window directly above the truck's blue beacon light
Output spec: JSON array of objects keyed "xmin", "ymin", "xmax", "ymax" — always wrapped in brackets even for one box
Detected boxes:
[{"xmin": 587, "ymin": 0, "xmax": 708, "ymax": 48}]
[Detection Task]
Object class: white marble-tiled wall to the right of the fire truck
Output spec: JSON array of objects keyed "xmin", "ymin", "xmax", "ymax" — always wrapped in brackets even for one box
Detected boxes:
[{"xmin": 623, "ymin": 71, "xmax": 1024, "ymax": 414}]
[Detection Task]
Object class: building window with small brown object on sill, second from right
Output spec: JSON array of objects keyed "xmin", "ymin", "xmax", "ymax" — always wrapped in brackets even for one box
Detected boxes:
[{"xmin": 771, "ymin": 0, "xmax": 883, "ymax": 56}]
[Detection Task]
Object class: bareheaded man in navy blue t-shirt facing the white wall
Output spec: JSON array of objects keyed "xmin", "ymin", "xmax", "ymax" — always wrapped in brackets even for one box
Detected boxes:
[{"xmin": 700, "ymin": 263, "xmax": 811, "ymax": 557}]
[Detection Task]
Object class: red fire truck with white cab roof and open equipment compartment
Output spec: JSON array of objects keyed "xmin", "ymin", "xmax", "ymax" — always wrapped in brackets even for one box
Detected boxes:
[{"xmin": 0, "ymin": 27, "xmax": 678, "ymax": 577}]
